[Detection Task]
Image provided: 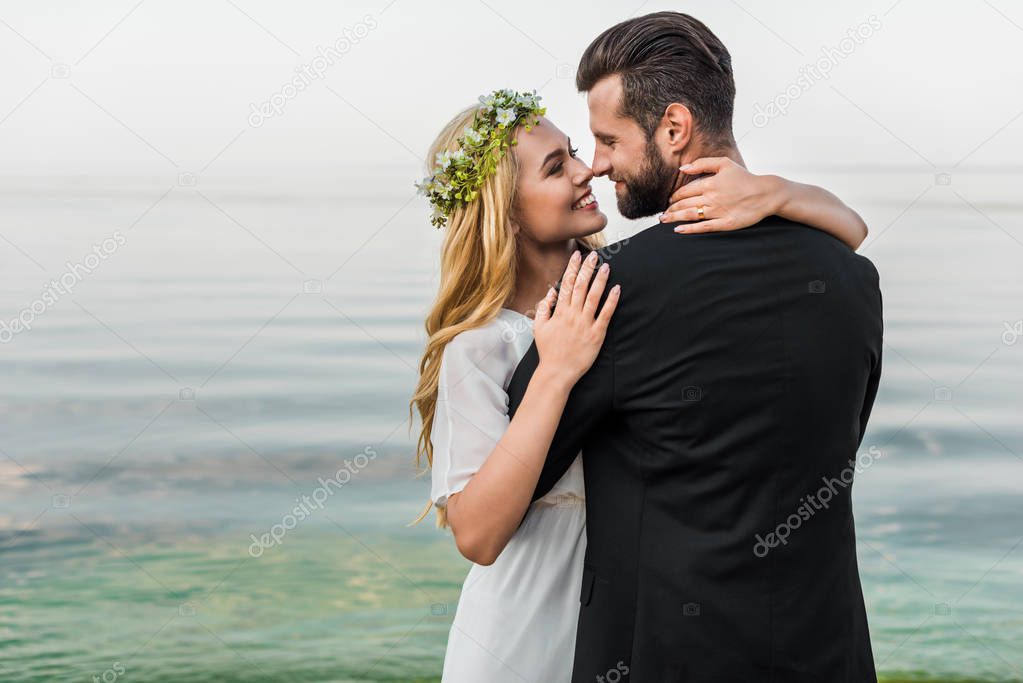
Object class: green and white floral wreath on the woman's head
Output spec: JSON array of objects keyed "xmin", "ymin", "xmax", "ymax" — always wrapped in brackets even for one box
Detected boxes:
[{"xmin": 415, "ymin": 90, "xmax": 547, "ymax": 228}]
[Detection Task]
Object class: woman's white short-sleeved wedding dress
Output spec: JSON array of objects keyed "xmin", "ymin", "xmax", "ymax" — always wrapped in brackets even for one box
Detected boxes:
[{"xmin": 431, "ymin": 309, "xmax": 586, "ymax": 683}]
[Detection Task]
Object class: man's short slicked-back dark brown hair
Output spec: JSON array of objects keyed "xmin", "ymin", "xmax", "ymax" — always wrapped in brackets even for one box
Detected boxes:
[{"xmin": 576, "ymin": 12, "xmax": 736, "ymax": 143}]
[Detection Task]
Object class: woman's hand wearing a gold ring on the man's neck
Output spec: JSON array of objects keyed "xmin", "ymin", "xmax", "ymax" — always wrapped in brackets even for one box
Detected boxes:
[{"xmin": 661, "ymin": 156, "xmax": 782, "ymax": 233}]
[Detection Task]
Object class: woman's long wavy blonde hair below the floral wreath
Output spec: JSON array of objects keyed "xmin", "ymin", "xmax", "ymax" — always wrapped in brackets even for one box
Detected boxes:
[{"xmin": 408, "ymin": 104, "xmax": 604, "ymax": 528}]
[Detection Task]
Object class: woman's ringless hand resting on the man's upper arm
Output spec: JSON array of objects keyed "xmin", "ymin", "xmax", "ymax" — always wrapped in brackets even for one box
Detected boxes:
[{"xmin": 533, "ymin": 252, "xmax": 621, "ymax": 384}]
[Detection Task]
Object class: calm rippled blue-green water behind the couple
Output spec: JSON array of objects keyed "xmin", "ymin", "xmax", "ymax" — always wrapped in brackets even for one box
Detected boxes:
[{"xmin": 0, "ymin": 181, "xmax": 1023, "ymax": 682}]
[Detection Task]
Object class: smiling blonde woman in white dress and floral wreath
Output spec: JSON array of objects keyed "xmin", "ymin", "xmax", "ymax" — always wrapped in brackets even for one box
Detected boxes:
[{"xmin": 410, "ymin": 90, "xmax": 866, "ymax": 683}]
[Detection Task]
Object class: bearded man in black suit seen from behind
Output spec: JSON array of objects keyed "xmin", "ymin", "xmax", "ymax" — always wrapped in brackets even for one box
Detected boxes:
[{"xmin": 508, "ymin": 12, "xmax": 882, "ymax": 683}]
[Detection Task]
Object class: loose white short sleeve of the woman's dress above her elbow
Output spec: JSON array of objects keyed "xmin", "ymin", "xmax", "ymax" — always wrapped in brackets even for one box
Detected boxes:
[{"xmin": 430, "ymin": 336, "xmax": 509, "ymax": 507}]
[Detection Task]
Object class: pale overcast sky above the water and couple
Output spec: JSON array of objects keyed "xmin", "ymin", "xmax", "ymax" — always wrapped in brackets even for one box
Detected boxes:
[{"xmin": 0, "ymin": 0, "xmax": 1023, "ymax": 192}]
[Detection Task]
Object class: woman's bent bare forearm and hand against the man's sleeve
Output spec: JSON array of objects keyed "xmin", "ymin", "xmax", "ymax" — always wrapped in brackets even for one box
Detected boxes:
[{"xmin": 447, "ymin": 252, "xmax": 620, "ymax": 564}]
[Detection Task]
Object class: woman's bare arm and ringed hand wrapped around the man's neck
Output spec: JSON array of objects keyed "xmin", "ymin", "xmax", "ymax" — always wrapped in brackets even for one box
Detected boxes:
[{"xmin": 661, "ymin": 156, "xmax": 866, "ymax": 249}]
